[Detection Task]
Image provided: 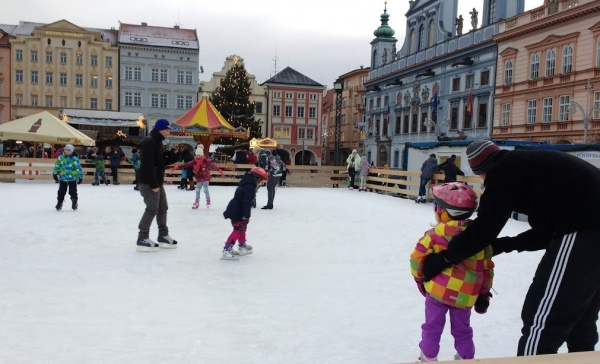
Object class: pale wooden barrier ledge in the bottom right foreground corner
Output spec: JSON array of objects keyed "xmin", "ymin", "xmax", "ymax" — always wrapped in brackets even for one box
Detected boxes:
[{"xmin": 406, "ymin": 351, "xmax": 600, "ymax": 364}]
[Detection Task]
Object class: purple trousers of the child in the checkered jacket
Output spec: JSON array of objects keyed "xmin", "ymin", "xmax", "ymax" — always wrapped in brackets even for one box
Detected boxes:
[{"xmin": 419, "ymin": 293, "xmax": 475, "ymax": 359}]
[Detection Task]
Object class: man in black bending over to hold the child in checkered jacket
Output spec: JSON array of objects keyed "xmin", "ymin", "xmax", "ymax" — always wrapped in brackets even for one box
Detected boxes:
[{"xmin": 424, "ymin": 140, "xmax": 600, "ymax": 356}]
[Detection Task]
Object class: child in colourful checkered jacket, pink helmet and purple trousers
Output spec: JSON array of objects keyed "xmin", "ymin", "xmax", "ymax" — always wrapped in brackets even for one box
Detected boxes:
[{"xmin": 410, "ymin": 182, "xmax": 494, "ymax": 362}]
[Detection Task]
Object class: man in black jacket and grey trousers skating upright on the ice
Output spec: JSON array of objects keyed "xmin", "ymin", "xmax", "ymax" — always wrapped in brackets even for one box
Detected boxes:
[{"xmin": 137, "ymin": 119, "xmax": 177, "ymax": 252}]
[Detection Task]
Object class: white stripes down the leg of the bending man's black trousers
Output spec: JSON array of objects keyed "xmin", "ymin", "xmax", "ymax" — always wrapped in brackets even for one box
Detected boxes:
[{"xmin": 523, "ymin": 232, "xmax": 577, "ymax": 356}]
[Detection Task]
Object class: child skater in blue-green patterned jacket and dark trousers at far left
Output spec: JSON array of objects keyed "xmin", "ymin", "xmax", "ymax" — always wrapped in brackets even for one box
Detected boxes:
[{"xmin": 52, "ymin": 144, "xmax": 83, "ymax": 211}]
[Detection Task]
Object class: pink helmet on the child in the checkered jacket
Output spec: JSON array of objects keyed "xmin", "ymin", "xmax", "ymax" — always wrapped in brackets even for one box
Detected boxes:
[{"xmin": 433, "ymin": 182, "xmax": 477, "ymax": 220}]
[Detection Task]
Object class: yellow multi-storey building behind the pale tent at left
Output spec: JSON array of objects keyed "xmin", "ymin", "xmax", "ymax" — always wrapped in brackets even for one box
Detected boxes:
[{"xmin": 10, "ymin": 20, "xmax": 119, "ymax": 120}]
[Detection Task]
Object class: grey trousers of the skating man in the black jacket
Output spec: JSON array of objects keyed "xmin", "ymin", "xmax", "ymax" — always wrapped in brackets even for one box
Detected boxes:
[{"xmin": 138, "ymin": 183, "xmax": 169, "ymax": 240}]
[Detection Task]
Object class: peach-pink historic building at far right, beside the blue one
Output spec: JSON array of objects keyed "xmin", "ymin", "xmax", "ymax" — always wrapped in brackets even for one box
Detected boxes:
[{"xmin": 492, "ymin": 0, "xmax": 600, "ymax": 144}]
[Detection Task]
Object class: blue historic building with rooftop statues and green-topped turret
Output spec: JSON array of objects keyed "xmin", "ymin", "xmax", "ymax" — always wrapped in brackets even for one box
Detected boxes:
[{"xmin": 365, "ymin": 0, "xmax": 524, "ymax": 168}]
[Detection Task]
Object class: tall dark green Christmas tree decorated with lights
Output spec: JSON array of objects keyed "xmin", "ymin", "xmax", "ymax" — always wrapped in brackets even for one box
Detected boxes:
[{"xmin": 210, "ymin": 62, "xmax": 261, "ymax": 144}]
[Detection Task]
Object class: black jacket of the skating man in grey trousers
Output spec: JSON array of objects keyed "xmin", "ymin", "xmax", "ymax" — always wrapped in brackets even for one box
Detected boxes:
[{"xmin": 139, "ymin": 129, "xmax": 165, "ymax": 188}]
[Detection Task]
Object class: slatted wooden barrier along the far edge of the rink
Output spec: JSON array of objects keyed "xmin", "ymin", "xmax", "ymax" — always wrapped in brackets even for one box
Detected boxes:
[{"xmin": 0, "ymin": 157, "xmax": 482, "ymax": 199}]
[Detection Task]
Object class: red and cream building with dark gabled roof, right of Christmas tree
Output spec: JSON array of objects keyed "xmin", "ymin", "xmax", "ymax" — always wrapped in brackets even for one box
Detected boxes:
[{"xmin": 262, "ymin": 67, "xmax": 325, "ymax": 165}]
